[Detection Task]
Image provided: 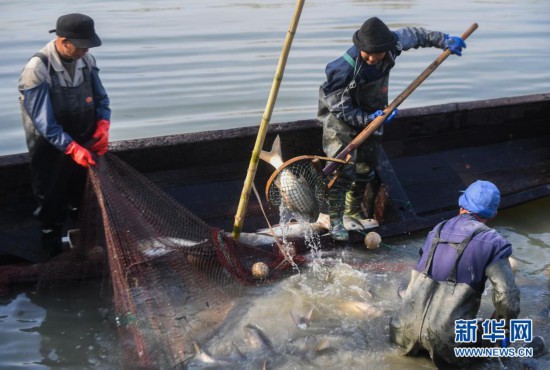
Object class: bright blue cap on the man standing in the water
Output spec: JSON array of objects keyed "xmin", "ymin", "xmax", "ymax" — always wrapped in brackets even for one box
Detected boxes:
[{"xmin": 458, "ymin": 180, "xmax": 500, "ymax": 219}]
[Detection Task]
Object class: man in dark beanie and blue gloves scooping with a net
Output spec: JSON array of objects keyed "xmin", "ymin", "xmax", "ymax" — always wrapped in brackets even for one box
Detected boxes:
[{"xmin": 317, "ymin": 17, "xmax": 466, "ymax": 241}]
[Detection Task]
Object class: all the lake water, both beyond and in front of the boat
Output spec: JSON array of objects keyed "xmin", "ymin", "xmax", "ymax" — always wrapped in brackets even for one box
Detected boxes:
[{"xmin": 0, "ymin": 0, "xmax": 550, "ymax": 369}]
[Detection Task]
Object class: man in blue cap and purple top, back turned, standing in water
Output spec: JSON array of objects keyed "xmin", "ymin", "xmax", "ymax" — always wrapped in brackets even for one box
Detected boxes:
[{"xmin": 390, "ymin": 180, "xmax": 544, "ymax": 369}]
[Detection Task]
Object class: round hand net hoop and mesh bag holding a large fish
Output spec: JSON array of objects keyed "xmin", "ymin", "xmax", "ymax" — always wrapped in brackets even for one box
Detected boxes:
[{"xmin": 266, "ymin": 156, "xmax": 328, "ymax": 222}]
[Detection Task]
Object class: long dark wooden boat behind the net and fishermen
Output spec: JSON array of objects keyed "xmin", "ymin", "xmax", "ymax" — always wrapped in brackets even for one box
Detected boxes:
[{"xmin": 0, "ymin": 93, "xmax": 550, "ymax": 263}]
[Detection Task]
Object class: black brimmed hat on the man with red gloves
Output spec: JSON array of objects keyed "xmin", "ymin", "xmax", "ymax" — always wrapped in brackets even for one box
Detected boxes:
[{"xmin": 50, "ymin": 13, "xmax": 101, "ymax": 49}]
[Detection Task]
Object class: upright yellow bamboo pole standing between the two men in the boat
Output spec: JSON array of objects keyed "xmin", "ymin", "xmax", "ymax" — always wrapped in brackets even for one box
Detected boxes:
[{"xmin": 232, "ymin": 0, "xmax": 304, "ymax": 240}]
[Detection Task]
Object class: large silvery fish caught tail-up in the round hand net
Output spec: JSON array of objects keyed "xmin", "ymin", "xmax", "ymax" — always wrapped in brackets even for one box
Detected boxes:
[{"xmin": 260, "ymin": 135, "xmax": 320, "ymax": 222}]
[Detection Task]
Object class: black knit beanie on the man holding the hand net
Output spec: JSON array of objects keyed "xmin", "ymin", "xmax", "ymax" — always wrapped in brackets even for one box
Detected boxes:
[{"xmin": 353, "ymin": 17, "xmax": 397, "ymax": 53}]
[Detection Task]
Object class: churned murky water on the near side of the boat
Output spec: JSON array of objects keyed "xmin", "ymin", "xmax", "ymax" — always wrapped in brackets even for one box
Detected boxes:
[{"xmin": 0, "ymin": 198, "xmax": 550, "ymax": 370}]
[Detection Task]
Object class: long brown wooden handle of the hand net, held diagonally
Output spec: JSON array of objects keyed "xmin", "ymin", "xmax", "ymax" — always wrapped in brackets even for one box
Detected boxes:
[{"xmin": 323, "ymin": 23, "xmax": 478, "ymax": 176}]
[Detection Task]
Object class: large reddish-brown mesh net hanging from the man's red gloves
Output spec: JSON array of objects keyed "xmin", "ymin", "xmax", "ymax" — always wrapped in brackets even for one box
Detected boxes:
[{"xmin": 57, "ymin": 153, "xmax": 301, "ymax": 369}]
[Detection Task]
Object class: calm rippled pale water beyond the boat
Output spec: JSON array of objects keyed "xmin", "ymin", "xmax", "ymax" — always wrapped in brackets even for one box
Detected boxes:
[{"xmin": 0, "ymin": 0, "xmax": 550, "ymax": 154}]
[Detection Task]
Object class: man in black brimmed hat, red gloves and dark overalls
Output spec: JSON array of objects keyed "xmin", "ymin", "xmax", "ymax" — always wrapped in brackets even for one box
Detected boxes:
[{"xmin": 18, "ymin": 13, "xmax": 111, "ymax": 257}]
